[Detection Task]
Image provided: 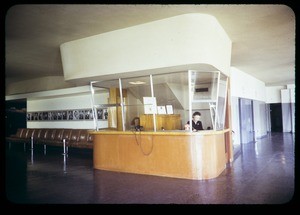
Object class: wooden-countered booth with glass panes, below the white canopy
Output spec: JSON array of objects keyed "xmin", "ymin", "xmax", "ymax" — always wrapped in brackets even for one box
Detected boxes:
[{"xmin": 90, "ymin": 70, "xmax": 233, "ymax": 180}]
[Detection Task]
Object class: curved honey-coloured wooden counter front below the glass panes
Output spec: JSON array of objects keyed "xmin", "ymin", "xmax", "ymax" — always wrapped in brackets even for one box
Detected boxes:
[{"xmin": 91, "ymin": 129, "xmax": 232, "ymax": 180}]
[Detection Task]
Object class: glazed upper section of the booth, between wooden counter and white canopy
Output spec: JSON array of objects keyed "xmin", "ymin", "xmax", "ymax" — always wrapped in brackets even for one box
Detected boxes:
[{"xmin": 91, "ymin": 70, "xmax": 228, "ymax": 131}]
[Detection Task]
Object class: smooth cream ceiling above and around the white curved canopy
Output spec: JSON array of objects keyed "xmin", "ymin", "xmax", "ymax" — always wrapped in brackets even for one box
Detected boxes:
[{"xmin": 5, "ymin": 4, "xmax": 295, "ymax": 95}]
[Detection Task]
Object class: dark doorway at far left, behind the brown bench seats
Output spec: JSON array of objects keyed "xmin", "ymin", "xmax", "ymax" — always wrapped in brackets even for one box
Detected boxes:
[{"xmin": 5, "ymin": 100, "xmax": 27, "ymax": 136}]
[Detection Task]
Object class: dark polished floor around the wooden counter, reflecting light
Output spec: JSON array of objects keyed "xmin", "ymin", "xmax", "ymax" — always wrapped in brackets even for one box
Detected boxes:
[{"xmin": 6, "ymin": 133, "xmax": 295, "ymax": 205}]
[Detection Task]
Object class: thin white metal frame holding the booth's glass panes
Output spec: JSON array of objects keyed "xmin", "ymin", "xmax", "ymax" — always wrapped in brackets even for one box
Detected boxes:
[{"xmin": 90, "ymin": 70, "xmax": 228, "ymax": 132}]
